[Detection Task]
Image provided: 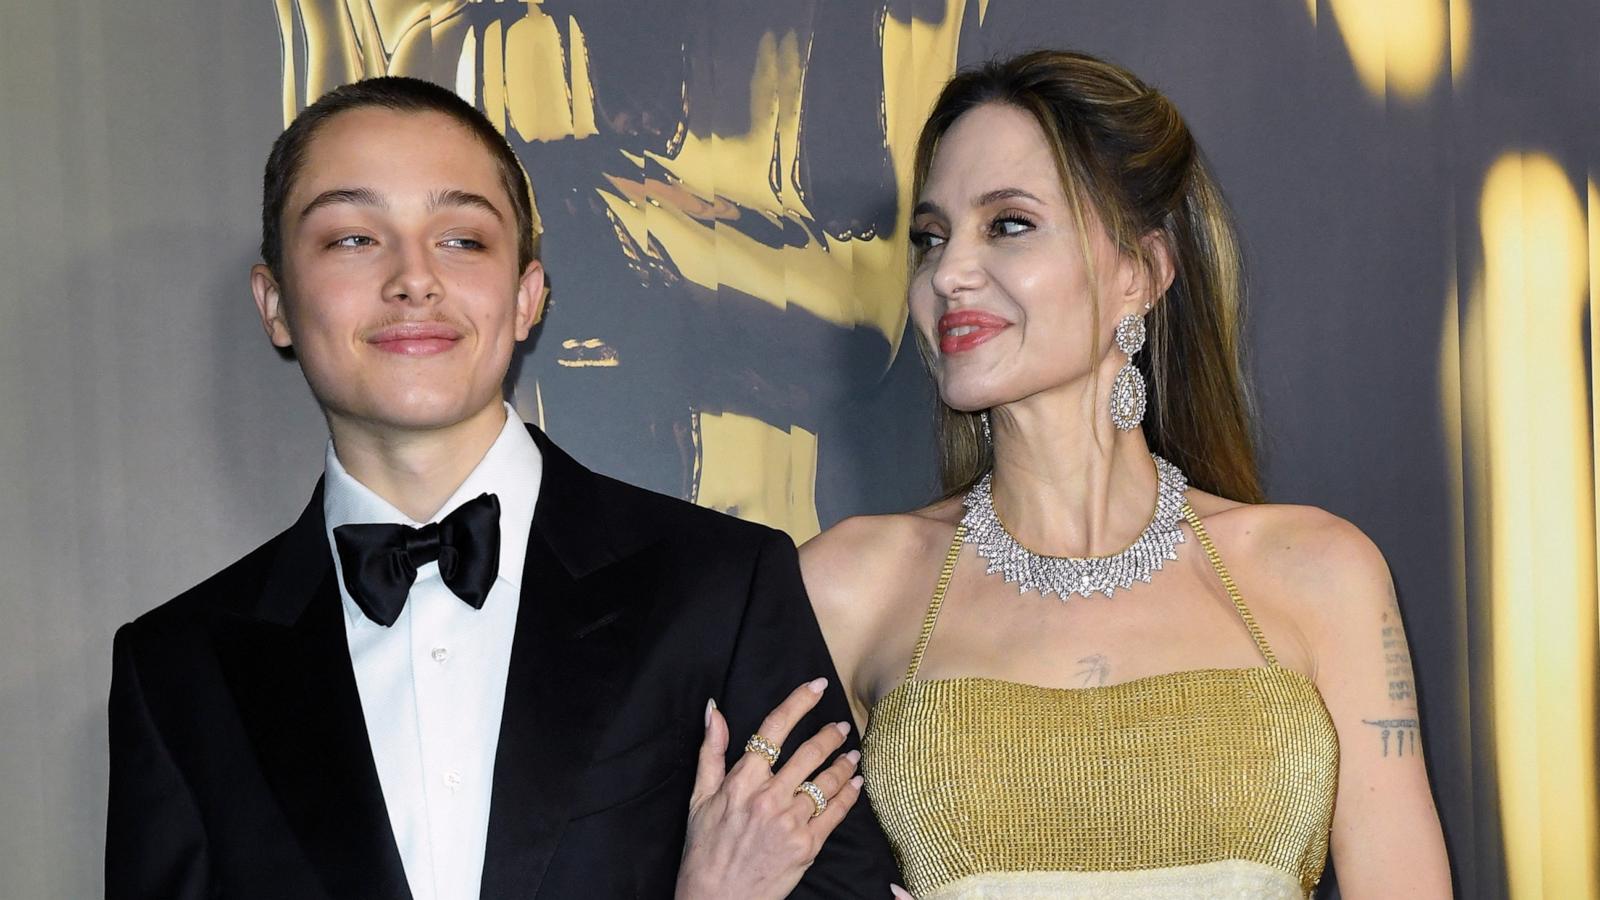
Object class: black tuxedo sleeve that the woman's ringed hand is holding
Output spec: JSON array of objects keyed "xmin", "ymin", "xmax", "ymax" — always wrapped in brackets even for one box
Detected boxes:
[{"xmin": 717, "ymin": 532, "xmax": 899, "ymax": 900}]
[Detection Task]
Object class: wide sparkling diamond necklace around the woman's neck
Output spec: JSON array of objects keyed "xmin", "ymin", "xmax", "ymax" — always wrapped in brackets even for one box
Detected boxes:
[{"xmin": 962, "ymin": 453, "xmax": 1189, "ymax": 601}]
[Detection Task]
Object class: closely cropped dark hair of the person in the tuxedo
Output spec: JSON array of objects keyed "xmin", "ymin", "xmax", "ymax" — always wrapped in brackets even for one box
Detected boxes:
[{"xmin": 261, "ymin": 75, "xmax": 539, "ymax": 277}]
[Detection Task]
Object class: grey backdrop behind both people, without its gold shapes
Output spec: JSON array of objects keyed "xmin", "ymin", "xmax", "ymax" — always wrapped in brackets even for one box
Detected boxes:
[{"xmin": 0, "ymin": 0, "xmax": 1600, "ymax": 898}]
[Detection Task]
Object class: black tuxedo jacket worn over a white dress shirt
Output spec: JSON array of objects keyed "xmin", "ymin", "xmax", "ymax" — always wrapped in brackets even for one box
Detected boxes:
[{"xmin": 106, "ymin": 428, "xmax": 896, "ymax": 900}]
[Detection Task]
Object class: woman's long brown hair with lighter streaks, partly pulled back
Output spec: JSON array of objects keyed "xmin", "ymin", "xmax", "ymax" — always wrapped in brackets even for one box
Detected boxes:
[{"xmin": 912, "ymin": 50, "xmax": 1262, "ymax": 503}]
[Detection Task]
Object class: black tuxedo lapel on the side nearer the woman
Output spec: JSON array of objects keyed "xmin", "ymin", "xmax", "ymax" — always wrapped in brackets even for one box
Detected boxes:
[{"xmin": 482, "ymin": 428, "xmax": 665, "ymax": 900}]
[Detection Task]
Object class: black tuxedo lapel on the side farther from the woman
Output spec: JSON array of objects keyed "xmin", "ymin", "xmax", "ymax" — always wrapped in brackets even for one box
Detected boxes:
[{"xmin": 218, "ymin": 484, "xmax": 411, "ymax": 900}]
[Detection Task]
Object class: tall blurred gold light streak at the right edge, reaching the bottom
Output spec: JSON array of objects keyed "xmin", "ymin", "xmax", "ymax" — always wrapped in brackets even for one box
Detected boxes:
[{"xmin": 1462, "ymin": 152, "xmax": 1600, "ymax": 897}]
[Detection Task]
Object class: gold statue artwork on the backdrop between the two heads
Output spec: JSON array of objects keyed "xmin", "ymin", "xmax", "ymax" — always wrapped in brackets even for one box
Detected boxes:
[{"xmin": 277, "ymin": 0, "xmax": 966, "ymax": 540}]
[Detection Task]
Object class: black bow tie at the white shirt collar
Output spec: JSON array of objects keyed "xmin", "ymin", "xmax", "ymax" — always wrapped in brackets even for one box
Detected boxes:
[{"xmin": 333, "ymin": 493, "xmax": 499, "ymax": 628}]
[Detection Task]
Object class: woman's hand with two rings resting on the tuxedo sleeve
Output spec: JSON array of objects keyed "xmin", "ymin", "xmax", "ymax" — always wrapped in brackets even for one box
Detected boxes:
[{"xmin": 677, "ymin": 677, "xmax": 861, "ymax": 900}]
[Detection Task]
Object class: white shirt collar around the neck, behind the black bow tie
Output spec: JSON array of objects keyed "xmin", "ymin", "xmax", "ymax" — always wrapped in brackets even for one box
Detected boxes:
[{"xmin": 322, "ymin": 404, "xmax": 544, "ymax": 621}]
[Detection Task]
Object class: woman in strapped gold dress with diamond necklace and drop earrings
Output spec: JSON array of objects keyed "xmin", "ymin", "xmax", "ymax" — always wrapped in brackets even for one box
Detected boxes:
[{"xmin": 802, "ymin": 51, "xmax": 1450, "ymax": 900}]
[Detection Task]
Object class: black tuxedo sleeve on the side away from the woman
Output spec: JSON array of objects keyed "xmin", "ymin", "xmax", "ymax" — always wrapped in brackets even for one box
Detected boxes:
[{"xmin": 106, "ymin": 626, "xmax": 210, "ymax": 900}]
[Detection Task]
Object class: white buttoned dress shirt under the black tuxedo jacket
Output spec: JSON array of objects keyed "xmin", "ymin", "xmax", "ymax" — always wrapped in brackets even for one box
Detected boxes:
[{"xmin": 323, "ymin": 405, "xmax": 542, "ymax": 900}]
